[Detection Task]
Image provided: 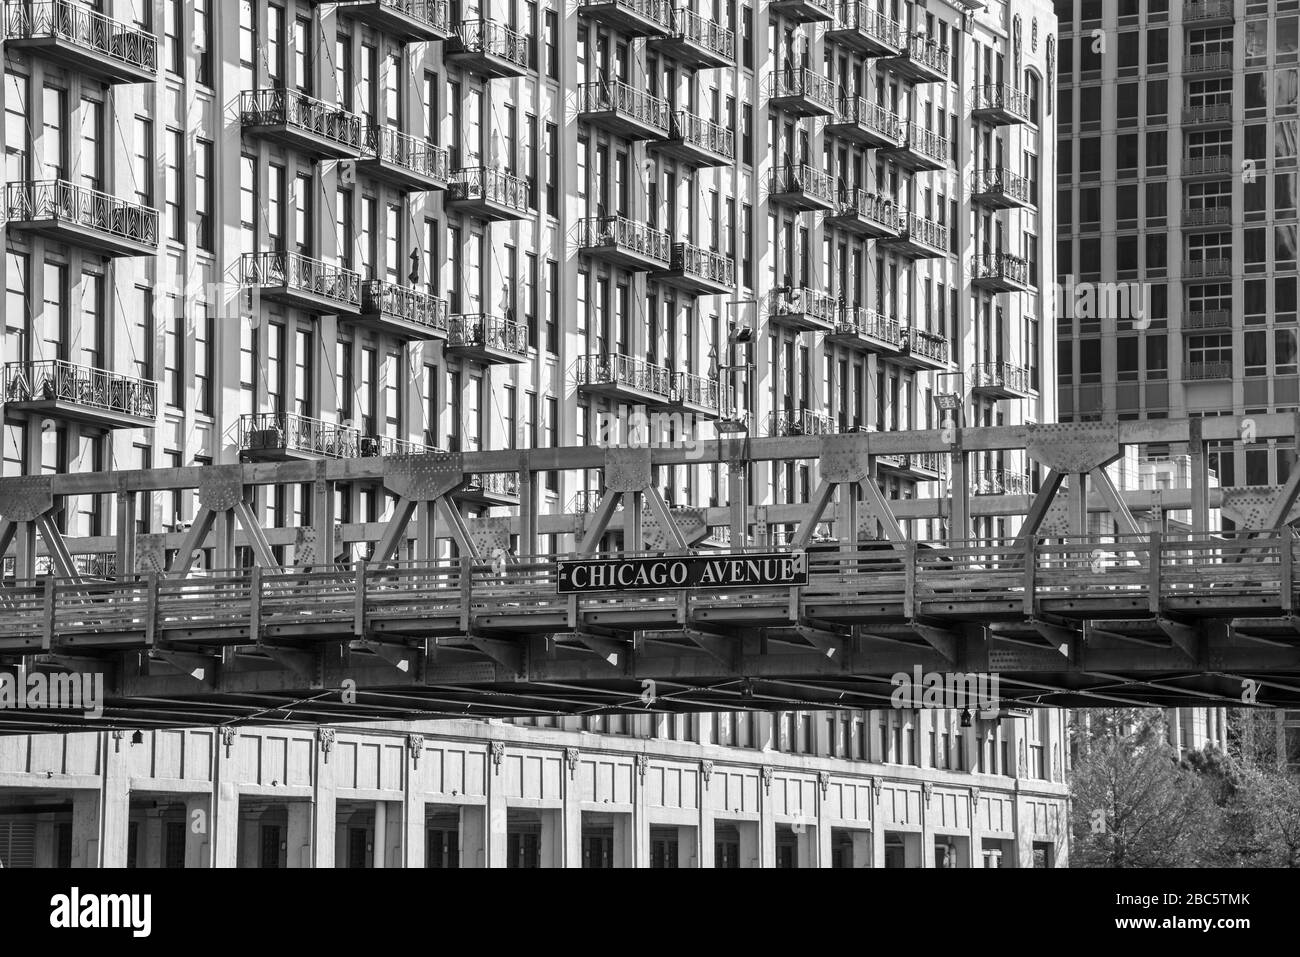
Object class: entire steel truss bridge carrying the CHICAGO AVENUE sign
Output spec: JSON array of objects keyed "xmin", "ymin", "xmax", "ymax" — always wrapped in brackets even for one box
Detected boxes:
[{"xmin": 0, "ymin": 415, "xmax": 1300, "ymax": 732}]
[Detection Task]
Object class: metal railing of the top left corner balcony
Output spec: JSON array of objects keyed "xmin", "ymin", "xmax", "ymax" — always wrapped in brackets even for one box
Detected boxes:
[{"xmin": 3, "ymin": 0, "xmax": 159, "ymax": 74}]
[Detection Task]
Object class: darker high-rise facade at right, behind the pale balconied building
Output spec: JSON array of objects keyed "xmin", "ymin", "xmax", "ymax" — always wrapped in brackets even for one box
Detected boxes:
[{"xmin": 1057, "ymin": 0, "xmax": 1300, "ymax": 486}]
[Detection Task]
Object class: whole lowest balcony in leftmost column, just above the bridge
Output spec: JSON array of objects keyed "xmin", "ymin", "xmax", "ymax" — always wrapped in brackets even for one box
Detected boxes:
[{"xmin": 4, "ymin": 359, "xmax": 159, "ymax": 429}]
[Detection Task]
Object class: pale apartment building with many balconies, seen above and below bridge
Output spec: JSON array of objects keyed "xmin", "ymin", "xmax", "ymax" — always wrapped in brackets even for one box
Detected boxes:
[{"xmin": 0, "ymin": 0, "xmax": 1066, "ymax": 866}]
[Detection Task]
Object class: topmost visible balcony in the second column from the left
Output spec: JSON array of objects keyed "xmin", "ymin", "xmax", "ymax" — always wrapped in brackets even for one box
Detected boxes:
[{"xmin": 239, "ymin": 90, "xmax": 361, "ymax": 160}]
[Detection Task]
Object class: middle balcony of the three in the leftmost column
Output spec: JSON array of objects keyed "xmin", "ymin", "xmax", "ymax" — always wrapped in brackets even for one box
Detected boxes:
[{"xmin": 4, "ymin": 179, "xmax": 159, "ymax": 256}]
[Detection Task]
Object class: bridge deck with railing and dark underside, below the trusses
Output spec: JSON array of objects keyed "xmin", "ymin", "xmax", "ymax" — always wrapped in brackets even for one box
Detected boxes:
[{"xmin": 0, "ymin": 531, "xmax": 1300, "ymax": 729}]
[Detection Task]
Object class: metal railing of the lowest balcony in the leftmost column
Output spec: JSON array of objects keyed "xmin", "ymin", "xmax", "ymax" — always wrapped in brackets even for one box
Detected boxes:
[{"xmin": 4, "ymin": 359, "xmax": 159, "ymax": 419}]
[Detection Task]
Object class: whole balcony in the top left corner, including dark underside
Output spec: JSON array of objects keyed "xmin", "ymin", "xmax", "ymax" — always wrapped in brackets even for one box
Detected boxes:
[{"xmin": 0, "ymin": 0, "xmax": 159, "ymax": 83}]
